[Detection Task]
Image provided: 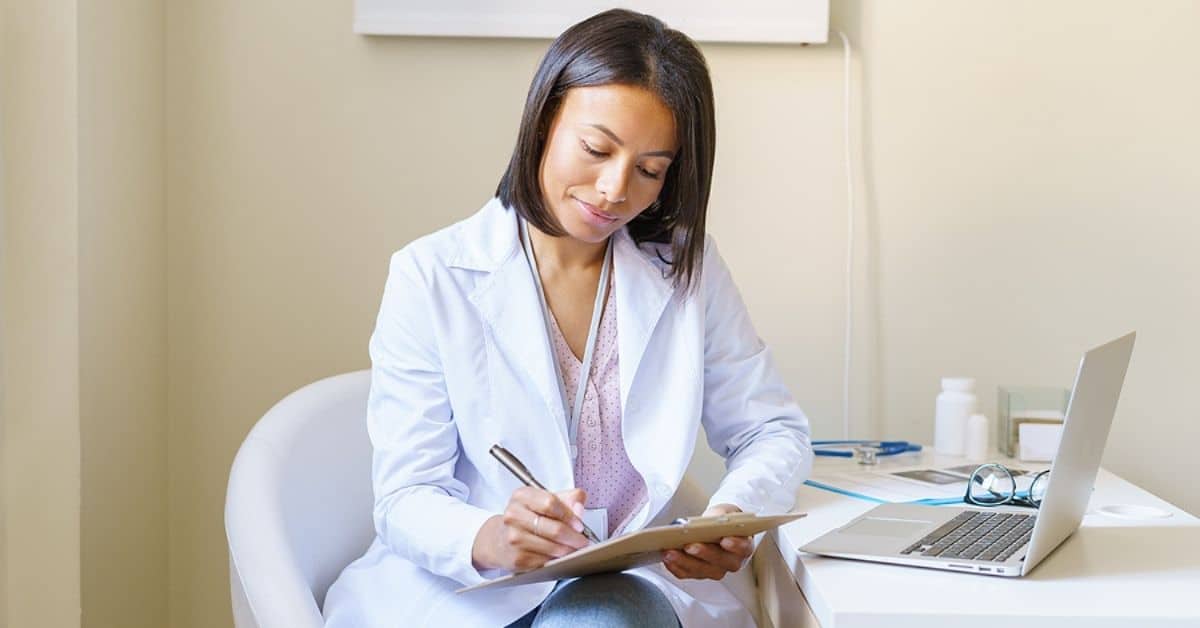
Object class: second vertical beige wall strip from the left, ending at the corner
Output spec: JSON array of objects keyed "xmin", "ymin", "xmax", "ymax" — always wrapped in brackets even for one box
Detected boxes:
[{"xmin": 79, "ymin": 0, "xmax": 168, "ymax": 628}]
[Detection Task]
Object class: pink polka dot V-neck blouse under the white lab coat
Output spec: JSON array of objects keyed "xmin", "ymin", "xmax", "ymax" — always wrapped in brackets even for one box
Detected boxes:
[{"xmin": 551, "ymin": 274, "xmax": 646, "ymax": 537}]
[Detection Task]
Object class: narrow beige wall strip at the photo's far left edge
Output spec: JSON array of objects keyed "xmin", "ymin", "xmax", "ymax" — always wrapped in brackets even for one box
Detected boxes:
[{"xmin": 0, "ymin": 0, "xmax": 80, "ymax": 628}]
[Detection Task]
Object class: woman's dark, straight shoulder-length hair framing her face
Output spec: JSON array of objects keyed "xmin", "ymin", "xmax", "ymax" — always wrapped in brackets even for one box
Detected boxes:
[{"xmin": 496, "ymin": 10, "xmax": 716, "ymax": 288}]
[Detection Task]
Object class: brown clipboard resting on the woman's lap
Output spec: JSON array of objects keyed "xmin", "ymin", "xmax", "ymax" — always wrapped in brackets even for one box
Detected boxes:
[{"xmin": 455, "ymin": 513, "xmax": 805, "ymax": 593}]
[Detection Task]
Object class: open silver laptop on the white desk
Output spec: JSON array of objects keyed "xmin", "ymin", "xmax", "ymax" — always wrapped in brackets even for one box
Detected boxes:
[{"xmin": 800, "ymin": 333, "xmax": 1136, "ymax": 576}]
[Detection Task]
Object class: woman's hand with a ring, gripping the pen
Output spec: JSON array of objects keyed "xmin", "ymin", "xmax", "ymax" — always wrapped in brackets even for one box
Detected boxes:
[{"xmin": 470, "ymin": 486, "xmax": 588, "ymax": 572}]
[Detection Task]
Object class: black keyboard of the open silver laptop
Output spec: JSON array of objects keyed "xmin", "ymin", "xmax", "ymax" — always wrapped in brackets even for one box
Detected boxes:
[{"xmin": 900, "ymin": 510, "xmax": 1037, "ymax": 562}]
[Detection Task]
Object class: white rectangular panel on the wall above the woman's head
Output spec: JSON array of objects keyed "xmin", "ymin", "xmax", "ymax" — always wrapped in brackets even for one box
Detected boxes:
[{"xmin": 354, "ymin": 0, "xmax": 829, "ymax": 43}]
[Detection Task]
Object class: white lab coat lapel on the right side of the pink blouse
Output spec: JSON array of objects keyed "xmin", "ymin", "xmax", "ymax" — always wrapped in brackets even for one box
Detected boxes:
[{"xmin": 613, "ymin": 229, "xmax": 673, "ymax": 413}]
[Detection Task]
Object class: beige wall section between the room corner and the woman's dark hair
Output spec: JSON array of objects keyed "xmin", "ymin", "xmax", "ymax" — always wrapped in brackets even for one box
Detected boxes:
[{"xmin": 167, "ymin": 1, "xmax": 545, "ymax": 627}]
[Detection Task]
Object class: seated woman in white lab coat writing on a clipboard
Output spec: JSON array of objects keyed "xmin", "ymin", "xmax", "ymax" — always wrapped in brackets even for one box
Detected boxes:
[{"xmin": 325, "ymin": 11, "xmax": 811, "ymax": 627}]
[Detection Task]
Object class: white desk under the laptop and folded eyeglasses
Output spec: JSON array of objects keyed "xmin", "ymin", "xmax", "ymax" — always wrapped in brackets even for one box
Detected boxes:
[{"xmin": 755, "ymin": 453, "xmax": 1200, "ymax": 628}]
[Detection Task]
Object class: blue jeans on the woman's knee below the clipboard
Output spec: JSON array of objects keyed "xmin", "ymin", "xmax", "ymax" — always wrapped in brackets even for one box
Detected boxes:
[{"xmin": 508, "ymin": 574, "xmax": 679, "ymax": 628}]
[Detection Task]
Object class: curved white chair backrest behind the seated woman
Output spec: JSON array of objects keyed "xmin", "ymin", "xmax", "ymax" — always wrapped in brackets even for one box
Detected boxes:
[{"xmin": 226, "ymin": 371, "xmax": 374, "ymax": 628}]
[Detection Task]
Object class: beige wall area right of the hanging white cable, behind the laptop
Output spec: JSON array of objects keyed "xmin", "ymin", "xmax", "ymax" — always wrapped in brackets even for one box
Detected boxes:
[{"xmin": 860, "ymin": 1, "xmax": 1200, "ymax": 513}]
